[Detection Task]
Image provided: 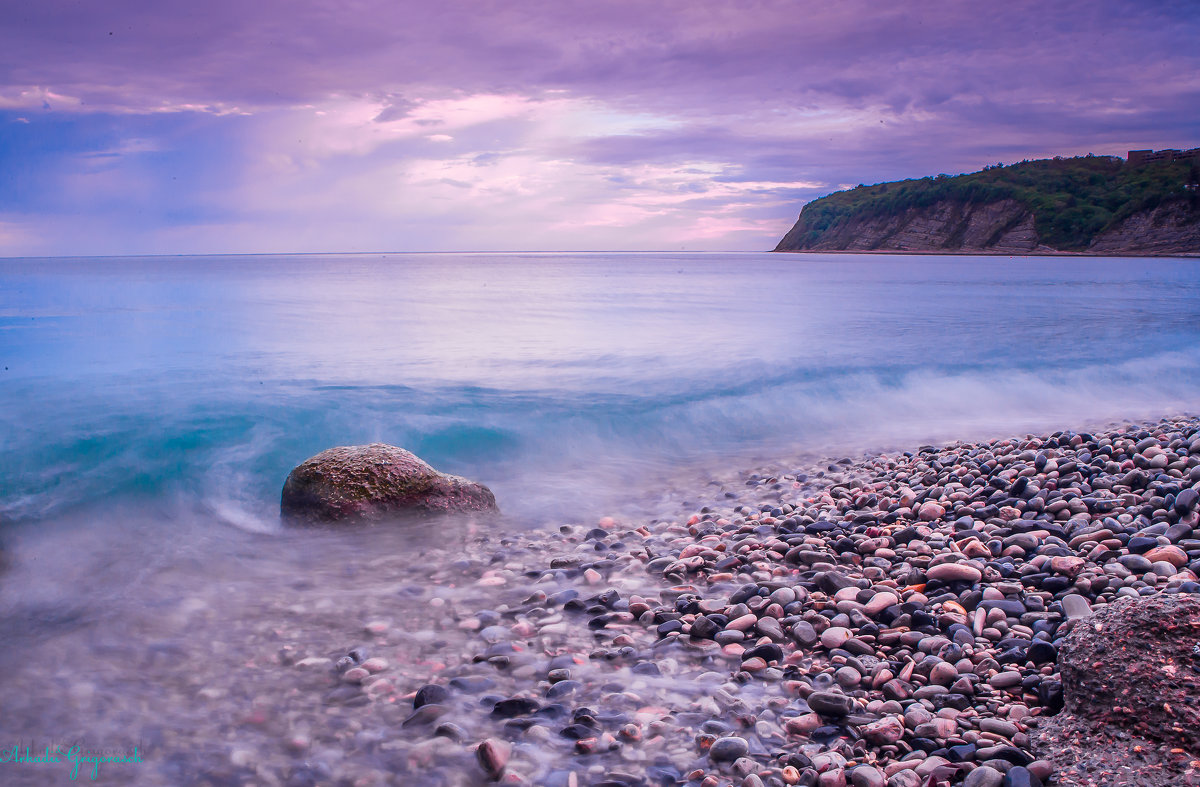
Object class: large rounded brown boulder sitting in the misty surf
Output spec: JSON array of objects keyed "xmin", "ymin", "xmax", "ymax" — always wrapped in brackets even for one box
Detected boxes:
[{"xmin": 280, "ymin": 443, "xmax": 497, "ymax": 524}]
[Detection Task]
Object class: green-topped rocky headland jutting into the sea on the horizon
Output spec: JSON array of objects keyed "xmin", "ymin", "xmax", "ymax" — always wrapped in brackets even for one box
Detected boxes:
[{"xmin": 775, "ymin": 157, "xmax": 1200, "ymax": 256}]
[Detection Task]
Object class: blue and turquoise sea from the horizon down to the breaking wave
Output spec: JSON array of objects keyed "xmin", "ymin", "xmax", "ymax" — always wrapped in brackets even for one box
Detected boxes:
[{"xmin": 0, "ymin": 253, "xmax": 1200, "ymax": 531}]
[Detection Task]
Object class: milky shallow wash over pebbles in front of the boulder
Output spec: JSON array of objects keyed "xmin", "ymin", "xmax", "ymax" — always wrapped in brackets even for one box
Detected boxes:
[{"xmin": 0, "ymin": 463, "xmax": 825, "ymax": 785}]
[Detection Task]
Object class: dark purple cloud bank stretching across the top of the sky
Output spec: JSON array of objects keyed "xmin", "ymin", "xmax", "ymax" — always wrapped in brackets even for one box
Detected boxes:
[{"xmin": 0, "ymin": 0, "xmax": 1198, "ymax": 120}]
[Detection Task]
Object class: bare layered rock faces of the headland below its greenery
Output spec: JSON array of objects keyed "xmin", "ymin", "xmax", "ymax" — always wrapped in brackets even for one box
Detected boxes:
[{"xmin": 775, "ymin": 199, "xmax": 1200, "ymax": 254}]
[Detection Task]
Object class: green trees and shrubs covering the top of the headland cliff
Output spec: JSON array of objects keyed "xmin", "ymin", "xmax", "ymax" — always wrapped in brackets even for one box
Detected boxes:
[{"xmin": 788, "ymin": 156, "xmax": 1200, "ymax": 251}]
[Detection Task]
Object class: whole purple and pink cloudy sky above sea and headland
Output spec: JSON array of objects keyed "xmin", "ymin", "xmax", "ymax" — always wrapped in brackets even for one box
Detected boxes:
[{"xmin": 0, "ymin": 0, "xmax": 1200, "ymax": 257}]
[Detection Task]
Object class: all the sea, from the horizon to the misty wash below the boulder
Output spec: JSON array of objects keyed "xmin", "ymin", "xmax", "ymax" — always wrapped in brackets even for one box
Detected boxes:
[{"xmin": 0, "ymin": 253, "xmax": 1200, "ymax": 783}]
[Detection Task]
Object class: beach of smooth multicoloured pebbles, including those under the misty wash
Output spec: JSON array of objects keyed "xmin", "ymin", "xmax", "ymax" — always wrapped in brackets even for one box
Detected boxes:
[{"xmin": 5, "ymin": 417, "xmax": 1200, "ymax": 787}]
